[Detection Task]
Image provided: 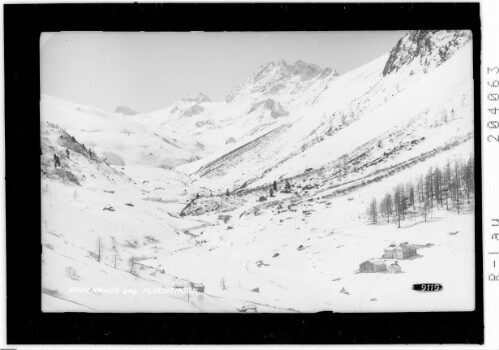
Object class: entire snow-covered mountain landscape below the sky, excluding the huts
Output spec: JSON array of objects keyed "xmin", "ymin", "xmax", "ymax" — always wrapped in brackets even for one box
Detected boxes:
[{"xmin": 41, "ymin": 31, "xmax": 475, "ymax": 313}]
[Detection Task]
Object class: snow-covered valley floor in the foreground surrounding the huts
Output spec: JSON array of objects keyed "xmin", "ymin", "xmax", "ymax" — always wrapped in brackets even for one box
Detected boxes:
[{"xmin": 42, "ymin": 161, "xmax": 475, "ymax": 312}]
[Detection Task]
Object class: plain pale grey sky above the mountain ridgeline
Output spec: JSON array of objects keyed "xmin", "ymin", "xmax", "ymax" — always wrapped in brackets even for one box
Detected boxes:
[{"xmin": 40, "ymin": 31, "xmax": 405, "ymax": 112}]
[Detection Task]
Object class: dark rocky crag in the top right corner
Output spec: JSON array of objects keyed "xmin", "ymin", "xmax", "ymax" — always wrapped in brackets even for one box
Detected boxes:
[{"xmin": 383, "ymin": 30, "xmax": 471, "ymax": 76}]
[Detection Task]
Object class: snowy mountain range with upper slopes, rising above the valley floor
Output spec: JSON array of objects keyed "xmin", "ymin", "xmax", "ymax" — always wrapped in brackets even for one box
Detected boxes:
[{"xmin": 42, "ymin": 31, "xmax": 473, "ymax": 193}]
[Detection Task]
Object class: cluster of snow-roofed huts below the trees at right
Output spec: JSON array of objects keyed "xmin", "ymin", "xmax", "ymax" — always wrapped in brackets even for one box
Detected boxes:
[{"xmin": 359, "ymin": 242, "xmax": 417, "ymax": 273}]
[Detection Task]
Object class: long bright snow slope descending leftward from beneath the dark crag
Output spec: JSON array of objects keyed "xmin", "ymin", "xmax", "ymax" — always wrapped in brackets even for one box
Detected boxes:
[{"xmin": 179, "ymin": 31, "xmax": 473, "ymax": 194}]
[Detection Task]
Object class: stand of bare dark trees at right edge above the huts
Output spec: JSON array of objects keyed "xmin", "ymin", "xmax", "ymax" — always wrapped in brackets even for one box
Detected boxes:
[{"xmin": 367, "ymin": 155, "xmax": 475, "ymax": 227}]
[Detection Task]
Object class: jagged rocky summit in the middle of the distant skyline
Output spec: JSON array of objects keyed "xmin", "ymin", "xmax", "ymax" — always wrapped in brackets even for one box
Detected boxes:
[{"xmin": 226, "ymin": 59, "xmax": 339, "ymax": 102}]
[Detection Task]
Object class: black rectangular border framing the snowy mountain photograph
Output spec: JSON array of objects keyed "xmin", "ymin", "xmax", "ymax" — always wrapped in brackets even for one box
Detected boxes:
[{"xmin": 4, "ymin": 3, "xmax": 484, "ymax": 344}]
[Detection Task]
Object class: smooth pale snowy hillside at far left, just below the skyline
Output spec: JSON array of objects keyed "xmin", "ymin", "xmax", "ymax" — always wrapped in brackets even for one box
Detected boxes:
[{"xmin": 40, "ymin": 95, "xmax": 210, "ymax": 168}]
